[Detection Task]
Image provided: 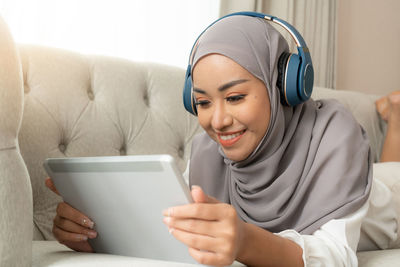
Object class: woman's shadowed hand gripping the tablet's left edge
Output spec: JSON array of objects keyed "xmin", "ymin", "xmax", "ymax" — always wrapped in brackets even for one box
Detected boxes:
[{"xmin": 45, "ymin": 178, "xmax": 97, "ymax": 252}]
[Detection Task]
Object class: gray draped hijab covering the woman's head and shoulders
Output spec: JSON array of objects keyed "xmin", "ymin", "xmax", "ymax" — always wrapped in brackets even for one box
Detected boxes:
[{"xmin": 189, "ymin": 16, "xmax": 372, "ymax": 234}]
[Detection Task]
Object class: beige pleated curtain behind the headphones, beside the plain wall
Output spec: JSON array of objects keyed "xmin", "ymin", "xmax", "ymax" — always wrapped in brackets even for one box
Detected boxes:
[{"xmin": 220, "ymin": 0, "xmax": 337, "ymax": 88}]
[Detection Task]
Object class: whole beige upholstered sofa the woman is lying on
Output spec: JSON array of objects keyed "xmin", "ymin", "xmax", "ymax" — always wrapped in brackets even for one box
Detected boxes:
[{"xmin": 0, "ymin": 18, "xmax": 400, "ymax": 267}]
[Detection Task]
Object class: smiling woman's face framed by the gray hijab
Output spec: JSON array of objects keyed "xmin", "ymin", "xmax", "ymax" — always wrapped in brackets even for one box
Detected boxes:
[{"xmin": 193, "ymin": 54, "xmax": 270, "ymax": 161}]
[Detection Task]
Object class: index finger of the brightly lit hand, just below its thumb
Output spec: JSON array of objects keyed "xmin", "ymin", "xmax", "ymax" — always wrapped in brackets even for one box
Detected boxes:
[{"xmin": 163, "ymin": 203, "xmax": 227, "ymax": 221}]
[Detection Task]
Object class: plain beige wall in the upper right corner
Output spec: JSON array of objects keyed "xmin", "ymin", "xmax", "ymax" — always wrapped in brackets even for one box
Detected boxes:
[{"xmin": 336, "ymin": 0, "xmax": 400, "ymax": 94}]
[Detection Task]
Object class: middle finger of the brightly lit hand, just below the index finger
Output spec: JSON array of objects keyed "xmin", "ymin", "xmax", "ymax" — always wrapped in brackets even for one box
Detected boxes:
[{"xmin": 163, "ymin": 217, "xmax": 219, "ymax": 237}]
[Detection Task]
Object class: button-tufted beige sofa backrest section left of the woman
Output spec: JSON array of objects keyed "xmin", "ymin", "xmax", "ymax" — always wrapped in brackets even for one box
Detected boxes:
[{"xmin": 19, "ymin": 46, "xmax": 199, "ymax": 239}]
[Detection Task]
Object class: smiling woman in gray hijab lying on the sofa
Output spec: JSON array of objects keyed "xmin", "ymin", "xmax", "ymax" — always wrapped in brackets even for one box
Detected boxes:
[{"xmin": 47, "ymin": 16, "xmax": 396, "ymax": 266}]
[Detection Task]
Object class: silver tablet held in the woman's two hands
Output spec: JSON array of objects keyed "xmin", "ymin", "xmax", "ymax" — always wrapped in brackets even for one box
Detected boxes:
[{"xmin": 44, "ymin": 155, "xmax": 195, "ymax": 263}]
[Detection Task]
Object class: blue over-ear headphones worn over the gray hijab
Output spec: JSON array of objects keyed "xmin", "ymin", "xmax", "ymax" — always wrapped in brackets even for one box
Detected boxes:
[{"xmin": 183, "ymin": 12, "xmax": 314, "ymax": 115}]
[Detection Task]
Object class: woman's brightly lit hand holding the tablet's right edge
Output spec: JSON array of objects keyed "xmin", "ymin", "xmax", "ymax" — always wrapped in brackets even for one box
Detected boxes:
[{"xmin": 163, "ymin": 186, "xmax": 245, "ymax": 266}]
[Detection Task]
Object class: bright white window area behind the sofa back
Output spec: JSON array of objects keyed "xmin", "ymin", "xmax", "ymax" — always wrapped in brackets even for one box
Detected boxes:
[{"xmin": 0, "ymin": 0, "xmax": 219, "ymax": 67}]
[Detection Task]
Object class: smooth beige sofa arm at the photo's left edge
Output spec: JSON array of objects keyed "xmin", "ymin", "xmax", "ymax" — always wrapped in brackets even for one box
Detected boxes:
[{"xmin": 0, "ymin": 18, "xmax": 32, "ymax": 266}]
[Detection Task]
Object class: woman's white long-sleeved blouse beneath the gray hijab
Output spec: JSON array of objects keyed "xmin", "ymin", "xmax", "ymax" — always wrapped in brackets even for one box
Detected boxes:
[{"xmin": 183, "ymin": 163, "xmax": 397, "ymax": 267}]
